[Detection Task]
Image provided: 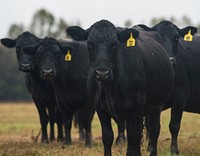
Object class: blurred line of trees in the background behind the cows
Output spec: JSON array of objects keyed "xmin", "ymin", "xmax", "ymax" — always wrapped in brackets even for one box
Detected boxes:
[{"xmin": 0, "ymin": 9, "xmax": 200, "ymax": 101}]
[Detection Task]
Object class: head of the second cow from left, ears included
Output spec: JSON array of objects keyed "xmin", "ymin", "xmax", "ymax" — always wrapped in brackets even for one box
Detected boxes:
[{"xmin": 24, "ymin": 37, "xmax": 73, "ymax": 79}]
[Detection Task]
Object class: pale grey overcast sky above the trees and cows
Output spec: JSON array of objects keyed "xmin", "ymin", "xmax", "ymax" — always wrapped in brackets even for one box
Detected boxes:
[{"xmin": 0, "ymin": 0, "xmax": 200, "ymax": 38}]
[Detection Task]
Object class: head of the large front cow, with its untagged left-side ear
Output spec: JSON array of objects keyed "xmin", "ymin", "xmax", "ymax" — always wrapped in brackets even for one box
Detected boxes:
[{"xmin": 67, "ymin": 20, "xmax": 139, "ymax": 81}]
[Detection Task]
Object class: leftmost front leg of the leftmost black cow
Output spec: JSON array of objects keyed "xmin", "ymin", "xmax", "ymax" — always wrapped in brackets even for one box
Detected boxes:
[{"xmin": 32, "ymin": 96, "xmax": 49, "ymax": 143}]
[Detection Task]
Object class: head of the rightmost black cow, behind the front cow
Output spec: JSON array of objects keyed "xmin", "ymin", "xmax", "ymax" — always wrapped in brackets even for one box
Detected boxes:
[{"xmin": 152, "ymin": 21, "xmax": 197, "ymax": 63}]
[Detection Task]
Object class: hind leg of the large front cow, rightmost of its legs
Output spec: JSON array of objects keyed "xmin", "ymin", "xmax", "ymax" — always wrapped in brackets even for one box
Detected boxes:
[{"xmin": 146, "ymin": 106, "xmax": 162, "ymax": 156}]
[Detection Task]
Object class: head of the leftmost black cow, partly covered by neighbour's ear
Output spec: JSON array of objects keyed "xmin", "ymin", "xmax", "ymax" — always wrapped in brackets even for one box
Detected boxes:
[{"xmin": 1, "ymin": 32, "xmax": 40, "ymax": 72}]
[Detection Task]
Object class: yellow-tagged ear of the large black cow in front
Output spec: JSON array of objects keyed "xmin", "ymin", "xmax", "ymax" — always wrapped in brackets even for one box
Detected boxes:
[{"xmin": 117, "ymin": 29, "xmax": 139, "ymax": 42}]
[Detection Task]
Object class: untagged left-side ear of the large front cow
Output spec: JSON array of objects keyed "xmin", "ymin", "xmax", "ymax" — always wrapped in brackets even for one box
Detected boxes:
[{"xmin": 66, "ymin": 26, "xmax": 88, "ymax": 41}]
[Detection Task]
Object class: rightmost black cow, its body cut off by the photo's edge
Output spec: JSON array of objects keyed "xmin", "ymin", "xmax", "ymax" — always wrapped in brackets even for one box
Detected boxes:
[{"xmin": 141, "ymin": 21, "xmax": 200, "ymax": 154}]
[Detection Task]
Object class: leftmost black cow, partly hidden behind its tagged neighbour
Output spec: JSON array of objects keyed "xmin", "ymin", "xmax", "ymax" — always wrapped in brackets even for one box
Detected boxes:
[{"xmin": 1, "ymin": 32, "xmax": 63, "ymax": 142}]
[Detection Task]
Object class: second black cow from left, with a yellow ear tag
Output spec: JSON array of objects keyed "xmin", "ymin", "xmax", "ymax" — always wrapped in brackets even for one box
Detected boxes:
[{"xmin": 24, "ymin": 38, "xmax": 94, "ymax": 146}]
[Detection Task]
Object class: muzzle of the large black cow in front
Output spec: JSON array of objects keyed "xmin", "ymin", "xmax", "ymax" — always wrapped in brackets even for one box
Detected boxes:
[{"xmin": 95, "ymin": 68, "xmax": 112, "ymax": 81}]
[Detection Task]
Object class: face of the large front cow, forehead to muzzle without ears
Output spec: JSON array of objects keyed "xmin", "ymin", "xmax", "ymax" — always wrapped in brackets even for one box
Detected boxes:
[{"xmin": 87, "ymin": 29, "xmax": 120, "ymax": 81}]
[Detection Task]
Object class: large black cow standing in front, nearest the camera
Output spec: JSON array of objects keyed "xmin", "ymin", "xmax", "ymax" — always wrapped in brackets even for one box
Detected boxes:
[{"xmin": 67, "ymin": 20, "xmax": 173, "ymax": 156}]
